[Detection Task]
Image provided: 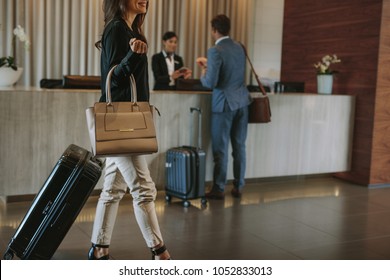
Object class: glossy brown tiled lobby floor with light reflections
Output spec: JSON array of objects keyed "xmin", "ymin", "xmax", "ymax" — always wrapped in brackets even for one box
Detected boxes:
[{"xmin": 0, "ymin": 176, "xmax": 390, "ymax": 260}]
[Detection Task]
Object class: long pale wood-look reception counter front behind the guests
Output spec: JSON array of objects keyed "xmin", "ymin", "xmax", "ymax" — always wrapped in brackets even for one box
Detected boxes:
[{"xmin": 0, "ymin": 88, "xmax": 355, "ymax": 197}]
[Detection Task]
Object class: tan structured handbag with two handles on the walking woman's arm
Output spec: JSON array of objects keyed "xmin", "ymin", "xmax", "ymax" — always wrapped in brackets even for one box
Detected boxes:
[{"xmin": 86, "ymin": 66, "xmax": 158, "ymax": 156}]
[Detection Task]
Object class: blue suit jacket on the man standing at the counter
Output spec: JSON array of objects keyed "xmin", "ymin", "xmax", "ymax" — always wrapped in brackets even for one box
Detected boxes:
[{"xmin": 201, "ymin": 38, "xmax": 250, "ymax": 112}]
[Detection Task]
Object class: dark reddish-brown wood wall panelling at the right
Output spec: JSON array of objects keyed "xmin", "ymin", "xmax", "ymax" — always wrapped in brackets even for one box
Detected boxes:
[{"xmin": 281, "ymin": 0, "xmax": 390, "ymax": 185}]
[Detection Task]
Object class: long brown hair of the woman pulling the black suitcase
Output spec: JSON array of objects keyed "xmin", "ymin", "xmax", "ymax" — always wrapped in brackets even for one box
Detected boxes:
[{"xmin": 95, "ymin": 0, "xmax": 149, "ymax": 49}]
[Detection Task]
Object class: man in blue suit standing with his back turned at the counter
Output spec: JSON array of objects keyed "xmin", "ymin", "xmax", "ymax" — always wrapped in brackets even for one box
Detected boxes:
[{"xmin": 198, "ymin": 15, "xmax": 250, "ymax": 199}]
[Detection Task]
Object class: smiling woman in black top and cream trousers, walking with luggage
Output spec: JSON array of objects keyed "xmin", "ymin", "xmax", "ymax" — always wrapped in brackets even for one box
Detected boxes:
[{"xmin": 88, "ymin": 0, "xmax": 170, "ymax": 260}]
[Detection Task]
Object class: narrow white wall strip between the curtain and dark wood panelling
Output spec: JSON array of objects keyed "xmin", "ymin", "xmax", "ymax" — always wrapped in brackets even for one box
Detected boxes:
[{"xmin": 251, "ymin": 0, "xmax": 284, "ymax": 87}]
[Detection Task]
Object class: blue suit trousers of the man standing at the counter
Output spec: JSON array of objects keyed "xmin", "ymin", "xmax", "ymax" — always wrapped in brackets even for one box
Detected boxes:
[{"xmin": 211, "ymin": 106, "xmax": 248, "ymax": 192}]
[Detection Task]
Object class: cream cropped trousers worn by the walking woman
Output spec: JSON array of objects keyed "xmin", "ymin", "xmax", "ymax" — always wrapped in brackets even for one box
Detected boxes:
[{"xmin": 91, "ymin": 156, "xmax": 163, "ymax": 248}]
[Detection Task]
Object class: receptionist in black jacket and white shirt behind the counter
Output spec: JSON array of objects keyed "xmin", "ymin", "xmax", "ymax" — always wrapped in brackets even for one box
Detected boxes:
[{"xmin": 152, "ymin": 31, "xmax": 192, "ymax": 90}]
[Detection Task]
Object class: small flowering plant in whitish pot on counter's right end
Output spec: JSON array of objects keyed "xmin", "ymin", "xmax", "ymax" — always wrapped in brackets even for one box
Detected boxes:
[{"xmin": 314, "ymin": 54, "xmax": 341, "ymax": 94}]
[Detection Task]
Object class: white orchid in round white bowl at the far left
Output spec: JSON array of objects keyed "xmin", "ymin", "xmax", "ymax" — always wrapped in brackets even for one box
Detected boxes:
[{"xmin": 0, "ymin": 25, "xmax": 30, "ymax": 87}]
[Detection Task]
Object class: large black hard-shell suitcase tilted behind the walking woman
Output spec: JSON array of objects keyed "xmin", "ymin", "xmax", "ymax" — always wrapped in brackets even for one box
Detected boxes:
[{"xmin": 4, "ymin": 144, "xmax": 103, "ymax": 260}]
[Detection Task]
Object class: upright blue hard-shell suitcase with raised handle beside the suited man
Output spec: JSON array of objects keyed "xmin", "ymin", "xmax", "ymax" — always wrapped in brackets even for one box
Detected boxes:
[{"xmin": 165, "ymin": 108, "xmax": 207, "ymax": 207}]
